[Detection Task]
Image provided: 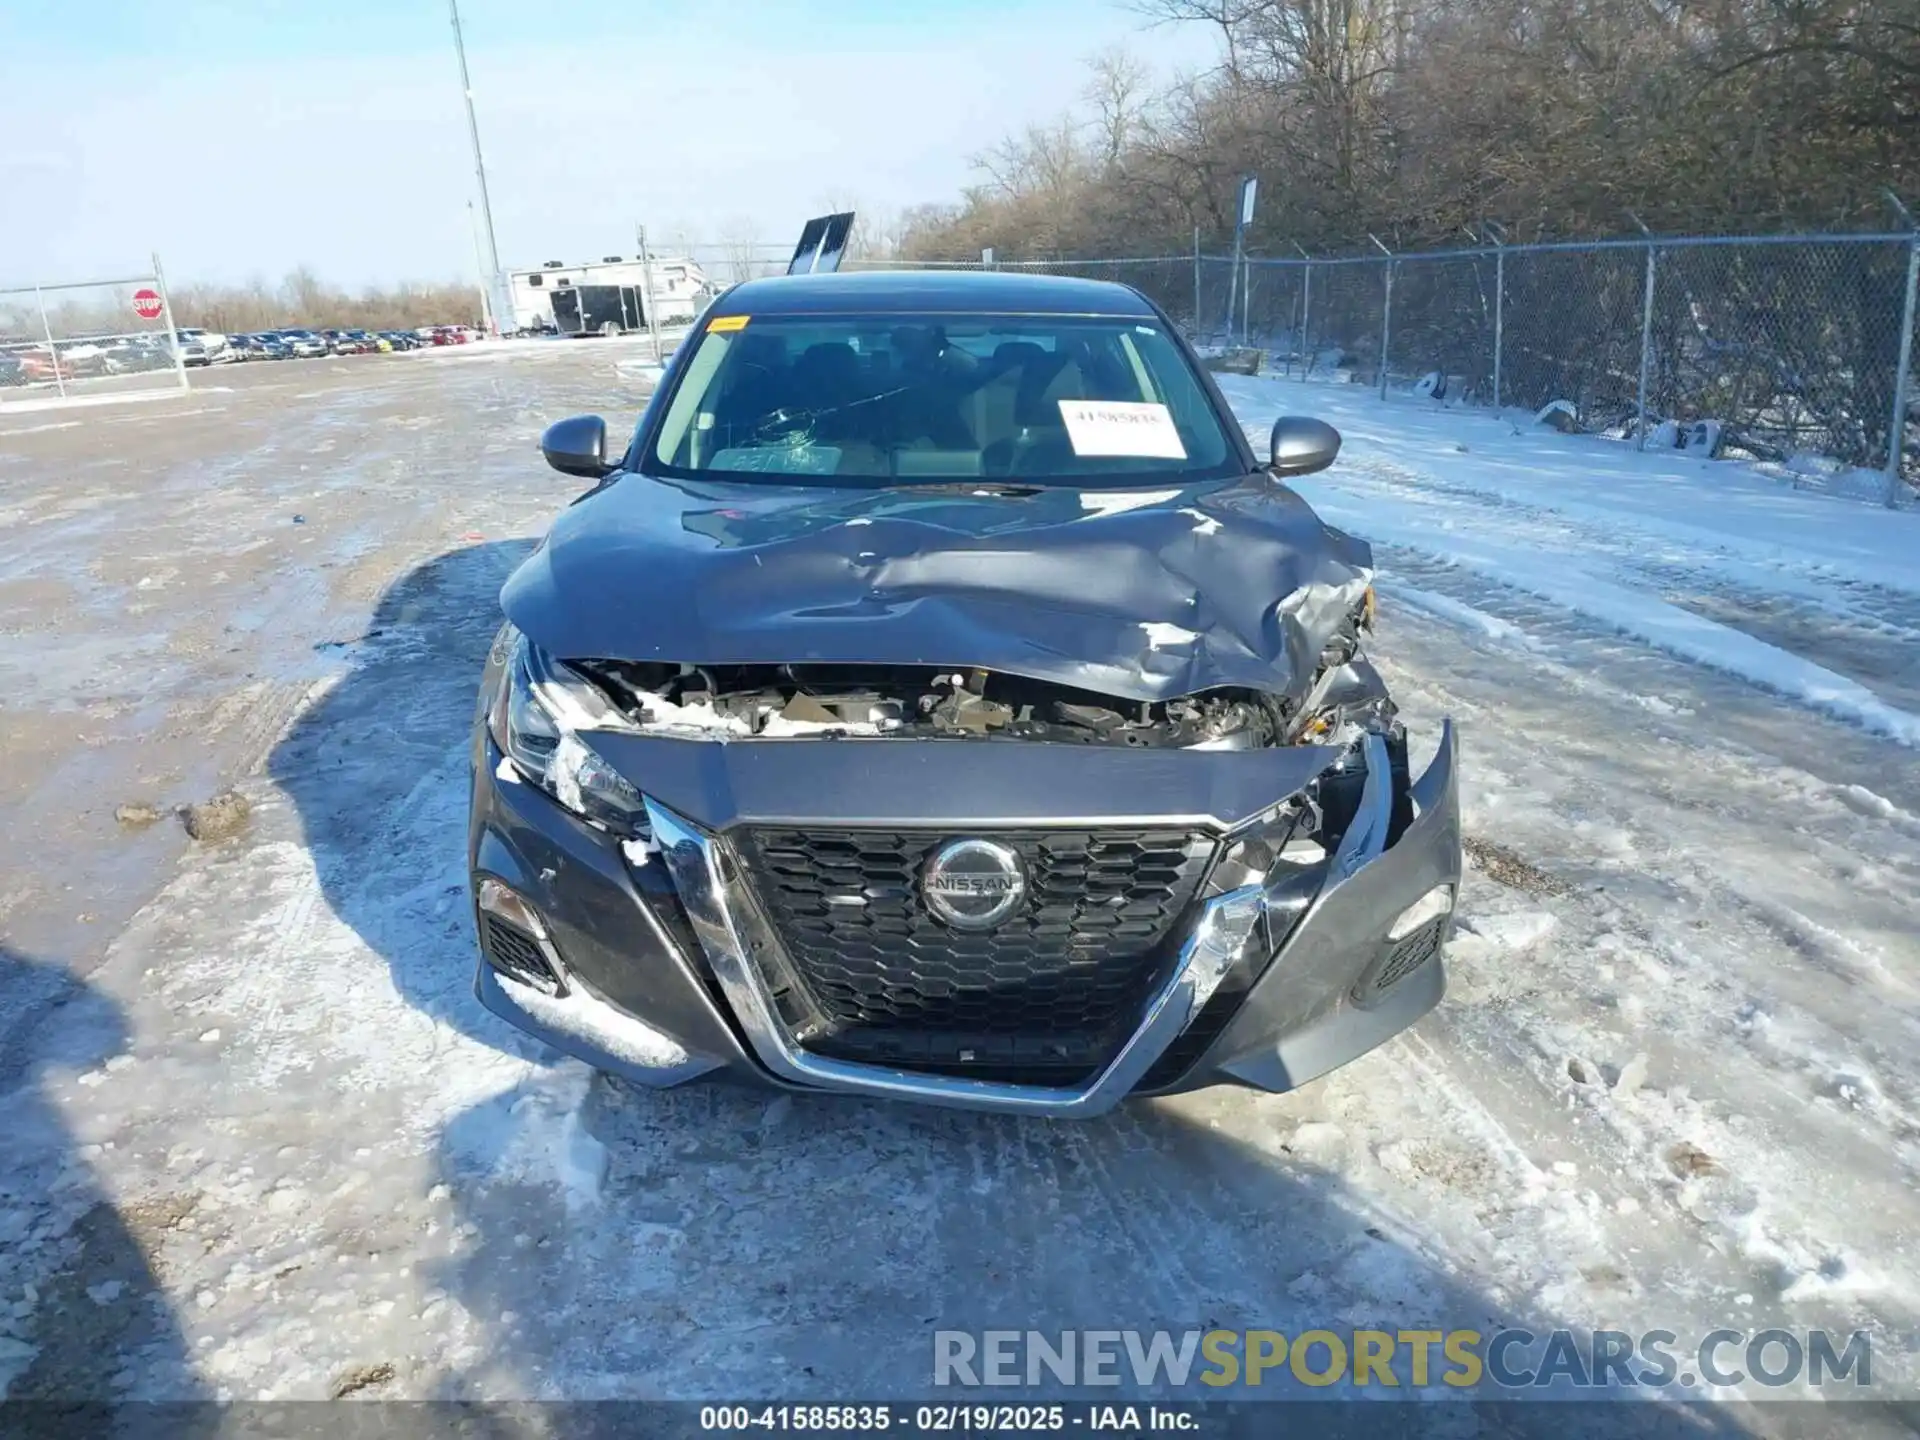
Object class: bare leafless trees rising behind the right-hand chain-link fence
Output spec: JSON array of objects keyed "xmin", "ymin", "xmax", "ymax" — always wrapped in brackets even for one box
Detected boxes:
[{"xmin": 900, "ymin": 0, "xmax": 1920, "ymax": 257}]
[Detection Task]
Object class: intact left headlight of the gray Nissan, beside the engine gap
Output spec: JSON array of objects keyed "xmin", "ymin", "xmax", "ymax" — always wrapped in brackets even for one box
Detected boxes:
[{"xmin": 492, "ymin": 636, "xmax": 647, "ymax": 837}]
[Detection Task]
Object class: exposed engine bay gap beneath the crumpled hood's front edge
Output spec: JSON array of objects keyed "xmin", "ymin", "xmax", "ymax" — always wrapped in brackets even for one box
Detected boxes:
[{"xmin": 568, "ymin": 591, "xmax": 1394, "ymax": 751}]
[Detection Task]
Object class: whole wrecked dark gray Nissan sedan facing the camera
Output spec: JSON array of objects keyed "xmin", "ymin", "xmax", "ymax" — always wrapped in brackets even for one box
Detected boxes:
[{"xmin": 470, "ymin": 276, "xmax": 1461, "ymax": 1116}]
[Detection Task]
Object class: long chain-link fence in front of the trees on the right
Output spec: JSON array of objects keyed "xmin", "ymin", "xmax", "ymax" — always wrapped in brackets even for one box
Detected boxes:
[{"xmin": 1198, "ymin": 234, "xmax": 1920, "ymax": 497}]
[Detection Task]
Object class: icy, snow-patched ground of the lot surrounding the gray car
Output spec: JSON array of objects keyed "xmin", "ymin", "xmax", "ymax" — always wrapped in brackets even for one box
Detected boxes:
[{"xmin": 0, "ymin": 344, "xmax": 1920, "ymax": 1432}]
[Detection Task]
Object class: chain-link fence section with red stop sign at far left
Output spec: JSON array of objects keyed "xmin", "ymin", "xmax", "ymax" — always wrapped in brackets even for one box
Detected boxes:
[{"xmin": 0, "ymin": 261, "xmax": 189, "ymax": 411}]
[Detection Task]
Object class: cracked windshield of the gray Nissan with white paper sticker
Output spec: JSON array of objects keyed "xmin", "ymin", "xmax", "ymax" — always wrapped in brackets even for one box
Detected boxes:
[{"xmin": 653, "ymin": 313, "xmax": 1240, "ymax": 488}]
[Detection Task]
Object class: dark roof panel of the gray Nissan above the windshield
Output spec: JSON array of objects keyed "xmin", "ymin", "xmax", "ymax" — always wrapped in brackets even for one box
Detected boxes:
[{"xmin": 712, "ymin": 271, "xmax": 1154, "ymax": 317}]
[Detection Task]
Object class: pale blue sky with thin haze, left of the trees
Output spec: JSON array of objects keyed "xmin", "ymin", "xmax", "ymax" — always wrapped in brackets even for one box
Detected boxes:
[{"xmin": 0, "ymin": 0, "xmax": 1212, "ymax": 284}]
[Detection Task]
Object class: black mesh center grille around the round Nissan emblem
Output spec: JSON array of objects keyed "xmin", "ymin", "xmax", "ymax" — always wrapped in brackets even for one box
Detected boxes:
[{"xmin": 741, "ymin": 829, "xmax": 1212, "ymax": 1085}]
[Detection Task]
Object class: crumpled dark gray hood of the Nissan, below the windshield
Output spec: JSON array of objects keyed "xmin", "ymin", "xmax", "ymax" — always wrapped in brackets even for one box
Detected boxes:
[{"xmin": 501, "ymin": 474, "xmax": 1373, "ymax": 701}]
